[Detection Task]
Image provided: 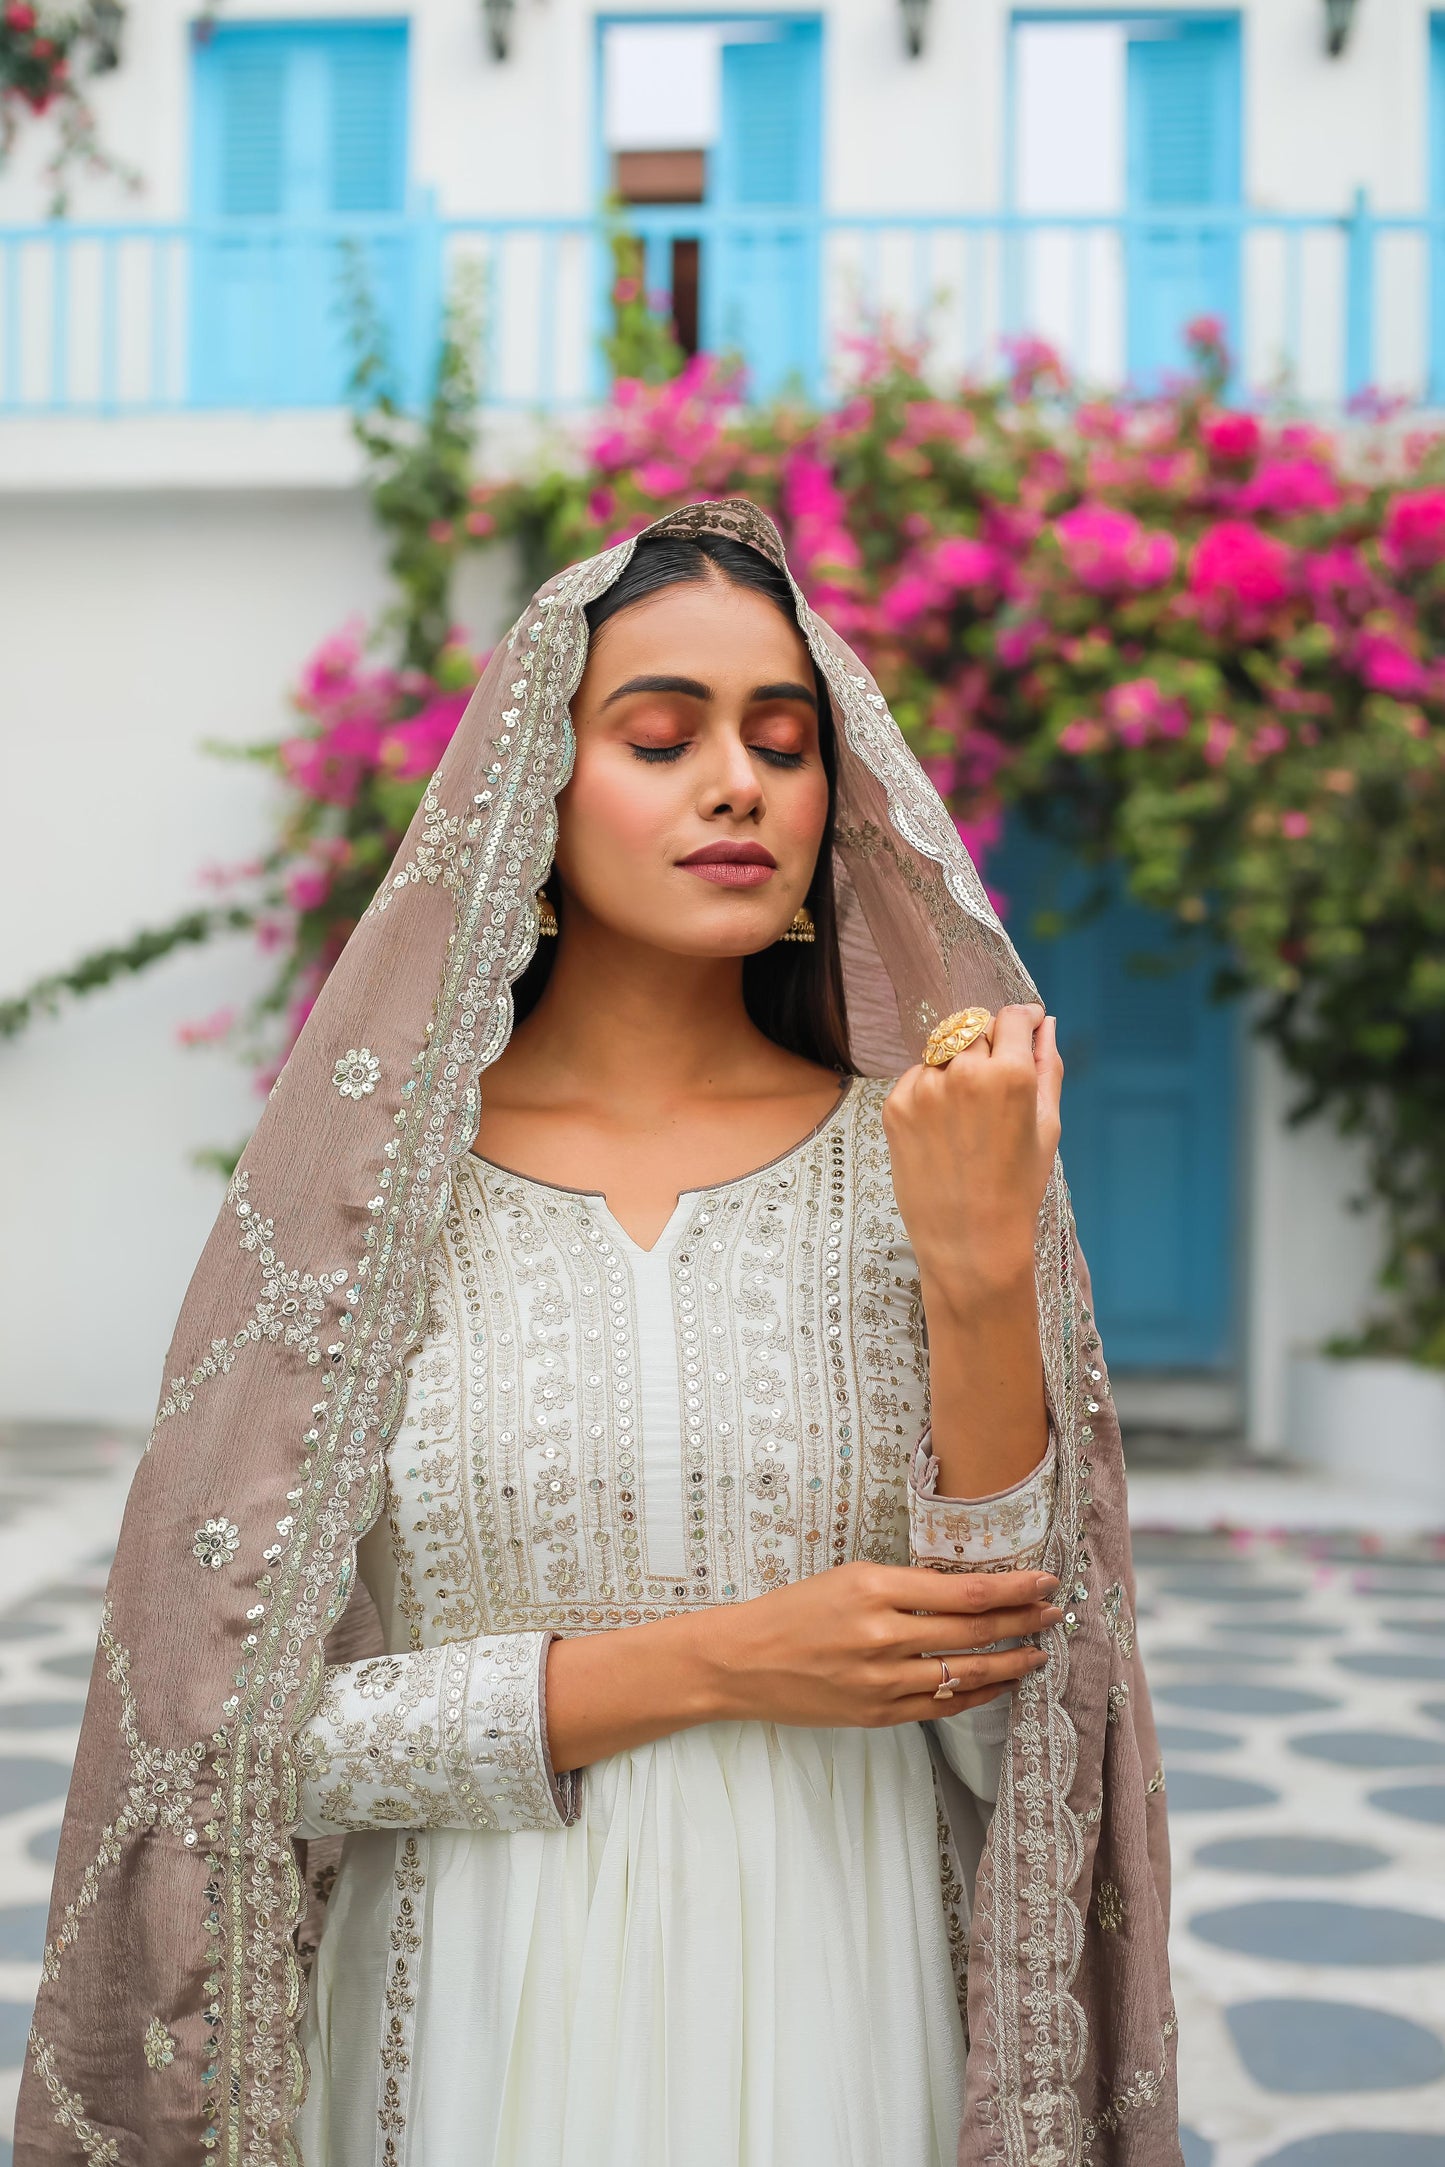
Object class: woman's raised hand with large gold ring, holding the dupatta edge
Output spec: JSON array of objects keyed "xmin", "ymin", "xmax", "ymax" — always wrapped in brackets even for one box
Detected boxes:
[{"xmin": 884, "ymin": 1001, "xmax": 1064, "ymax": 1309}]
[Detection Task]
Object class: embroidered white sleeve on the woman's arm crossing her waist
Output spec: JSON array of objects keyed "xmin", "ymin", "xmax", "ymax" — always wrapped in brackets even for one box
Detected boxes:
[{"xmin": 297, "ymin": 1632, "xmax": 581, "ymax": 1835}]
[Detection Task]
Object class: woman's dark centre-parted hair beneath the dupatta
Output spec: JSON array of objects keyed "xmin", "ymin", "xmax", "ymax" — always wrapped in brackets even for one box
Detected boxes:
[{"xmin": 516, "ymin": 535, "xmax": 854, "ymax": 1075}]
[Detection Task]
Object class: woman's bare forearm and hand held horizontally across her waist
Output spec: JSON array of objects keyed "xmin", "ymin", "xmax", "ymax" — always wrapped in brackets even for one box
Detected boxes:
[{"xmin": 546, "ymin": 1562, "xmax": 1062, "ymax": 1768}]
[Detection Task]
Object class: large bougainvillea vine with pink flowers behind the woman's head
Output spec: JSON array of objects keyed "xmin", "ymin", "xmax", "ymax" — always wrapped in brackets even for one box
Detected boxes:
[{"xmin": 0, "ymin": 309, "xmax": 1445, "ymax": 1365}]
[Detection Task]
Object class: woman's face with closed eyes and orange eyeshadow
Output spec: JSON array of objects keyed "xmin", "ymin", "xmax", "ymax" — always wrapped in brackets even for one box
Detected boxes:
[{"xmin": 557, "ymin": 579, "xmax": 828, "ymax": 956}]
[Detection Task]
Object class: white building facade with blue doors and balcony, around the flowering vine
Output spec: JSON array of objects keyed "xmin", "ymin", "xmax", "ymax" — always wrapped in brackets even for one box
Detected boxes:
[{"xmin": 0, "ymin": 0, "xmax": 1403, "ymax": 1450}]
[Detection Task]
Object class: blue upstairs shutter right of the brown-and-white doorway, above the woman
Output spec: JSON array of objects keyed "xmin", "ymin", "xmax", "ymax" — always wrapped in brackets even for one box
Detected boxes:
[{"xmin": 702, "ymin": 22, "xmax": 821, "ymax": 399}]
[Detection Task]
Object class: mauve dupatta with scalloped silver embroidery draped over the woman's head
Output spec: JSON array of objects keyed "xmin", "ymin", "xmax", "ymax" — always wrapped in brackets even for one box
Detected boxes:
[{"xmin": 15, "ymin": 501, "xmax": 1179, "ymax": 2167}]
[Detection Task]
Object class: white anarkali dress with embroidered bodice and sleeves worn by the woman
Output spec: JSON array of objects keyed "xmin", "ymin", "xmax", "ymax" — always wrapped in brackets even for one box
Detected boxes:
[{"xmin": 297, "ymin": 1081, "xmax": 1053, "ymax": 2167}]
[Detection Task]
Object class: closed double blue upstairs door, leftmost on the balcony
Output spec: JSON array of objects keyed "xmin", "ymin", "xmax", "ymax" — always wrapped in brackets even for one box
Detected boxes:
[{"xmin": 191, "ymin": 24, "xmax": 412, "ymax": 407}]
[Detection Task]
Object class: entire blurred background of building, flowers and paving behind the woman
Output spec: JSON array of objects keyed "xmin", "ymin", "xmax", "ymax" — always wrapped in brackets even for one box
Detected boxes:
[{"xmin": 0, "ymin": 0, "xmax": 1445, "ymax": 2167}]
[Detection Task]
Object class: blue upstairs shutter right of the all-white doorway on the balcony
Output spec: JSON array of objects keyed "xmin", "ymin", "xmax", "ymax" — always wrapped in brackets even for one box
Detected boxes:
[{"xmin": 1124, "ymin": 17, "xmax": 1239, "ymax": 386}]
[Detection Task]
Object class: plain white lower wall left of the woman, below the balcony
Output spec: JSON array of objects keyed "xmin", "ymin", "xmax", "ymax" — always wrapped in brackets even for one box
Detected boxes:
[{"xmin": 0, "ymin": 492, "xmax": 507, "ymax": 1422}]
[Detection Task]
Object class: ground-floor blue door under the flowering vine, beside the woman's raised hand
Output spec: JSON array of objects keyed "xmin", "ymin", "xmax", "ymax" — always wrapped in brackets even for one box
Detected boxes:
[{"xmin": 988, "ymin": 830, "xmax": 1239, "ymax": 1370}]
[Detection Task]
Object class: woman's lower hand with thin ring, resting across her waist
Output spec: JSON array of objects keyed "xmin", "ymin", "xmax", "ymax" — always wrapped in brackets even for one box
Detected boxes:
[{"xmin": 698, "ymin": 1562, "xmax": 1064, "ymax": 1729}]
